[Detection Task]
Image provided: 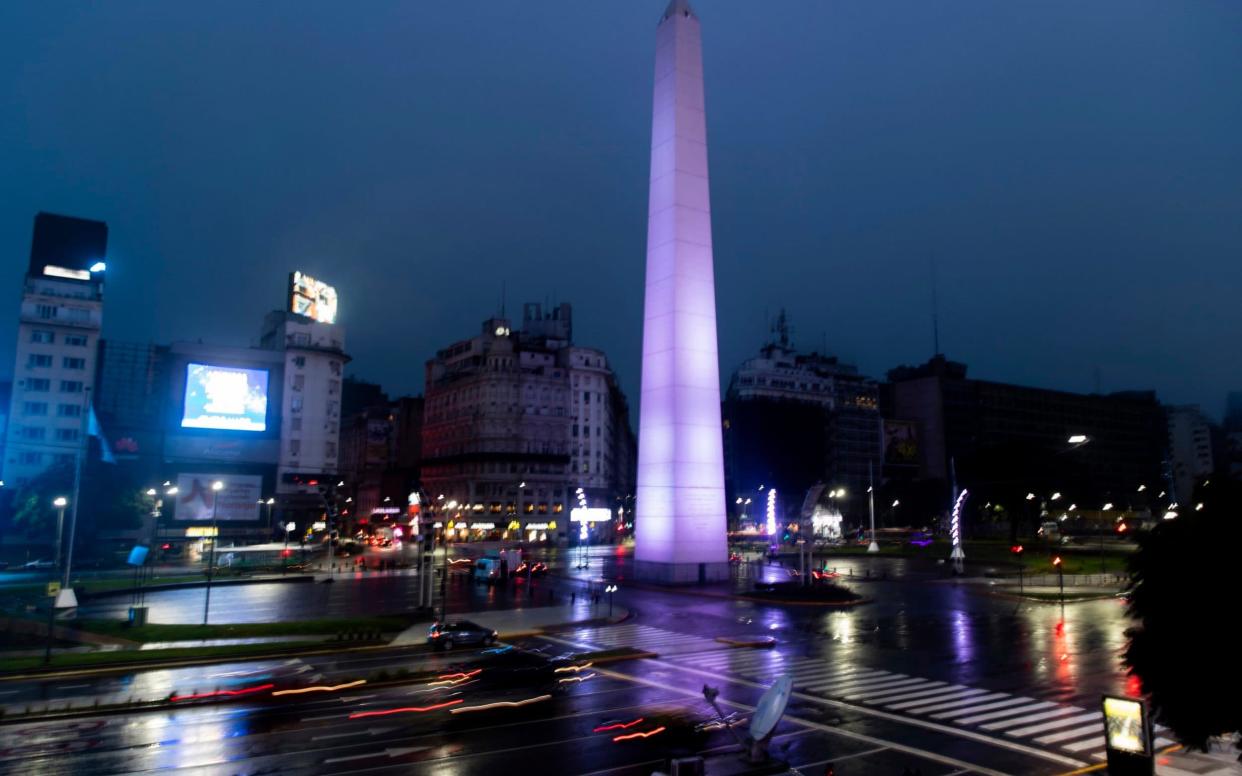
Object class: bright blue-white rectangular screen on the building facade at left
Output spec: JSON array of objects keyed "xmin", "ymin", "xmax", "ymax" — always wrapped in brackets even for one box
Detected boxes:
[{"xmin": 181, "ymin": 361, "xmax": 267, "ymax": 431}]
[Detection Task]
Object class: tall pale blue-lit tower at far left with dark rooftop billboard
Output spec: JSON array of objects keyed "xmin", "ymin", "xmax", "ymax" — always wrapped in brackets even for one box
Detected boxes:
[{"xmin": 0, "ymin": 212, "xmax": 108, "ymax": 488}]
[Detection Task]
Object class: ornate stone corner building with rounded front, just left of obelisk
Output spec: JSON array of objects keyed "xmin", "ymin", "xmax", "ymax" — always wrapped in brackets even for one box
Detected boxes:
[{"xmin": 421, "ymin": 304, "xmax": 632, "ymax": 541}]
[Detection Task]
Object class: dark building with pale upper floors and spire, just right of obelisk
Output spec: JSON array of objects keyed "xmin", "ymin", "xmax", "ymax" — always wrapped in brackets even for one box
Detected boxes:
[{"xmin": 723, "ymin": 313, "xmax": 883, "ymax": 523}]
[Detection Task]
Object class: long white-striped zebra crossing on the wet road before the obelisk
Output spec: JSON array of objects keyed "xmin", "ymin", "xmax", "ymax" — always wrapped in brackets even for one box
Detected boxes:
[{"xmin": 653, "ymin": 645, "xmax": 1174, "ymax": 760}]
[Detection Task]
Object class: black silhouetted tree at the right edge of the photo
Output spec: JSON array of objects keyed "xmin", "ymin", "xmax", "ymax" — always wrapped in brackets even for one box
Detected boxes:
[{"xmin": 1124, "ymin": 480, "xmax": 1242, "ymax": 749}]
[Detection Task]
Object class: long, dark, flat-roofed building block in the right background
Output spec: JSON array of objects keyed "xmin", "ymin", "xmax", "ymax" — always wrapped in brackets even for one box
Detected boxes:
[{"xmin": 883, "ymin": 355, "xmax": 1167, "ymax": 509}]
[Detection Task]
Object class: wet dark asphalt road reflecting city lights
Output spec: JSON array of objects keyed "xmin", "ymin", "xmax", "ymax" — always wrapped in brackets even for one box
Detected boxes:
[{"xmin": 0, "ymin": 551, "xmax": 1134, "ymax": 774}]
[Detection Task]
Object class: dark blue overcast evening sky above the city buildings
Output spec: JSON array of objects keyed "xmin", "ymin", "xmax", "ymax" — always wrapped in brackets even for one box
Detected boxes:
[{"xmin": 0, "ymin": 0, "xmax": 1242, "ymax": 415}]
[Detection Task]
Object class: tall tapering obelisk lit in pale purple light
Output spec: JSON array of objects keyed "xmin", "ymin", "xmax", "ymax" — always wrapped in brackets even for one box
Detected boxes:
[{"xmin": 635, "ymin": 0, "xmax": 729, "ymax": 584}]
